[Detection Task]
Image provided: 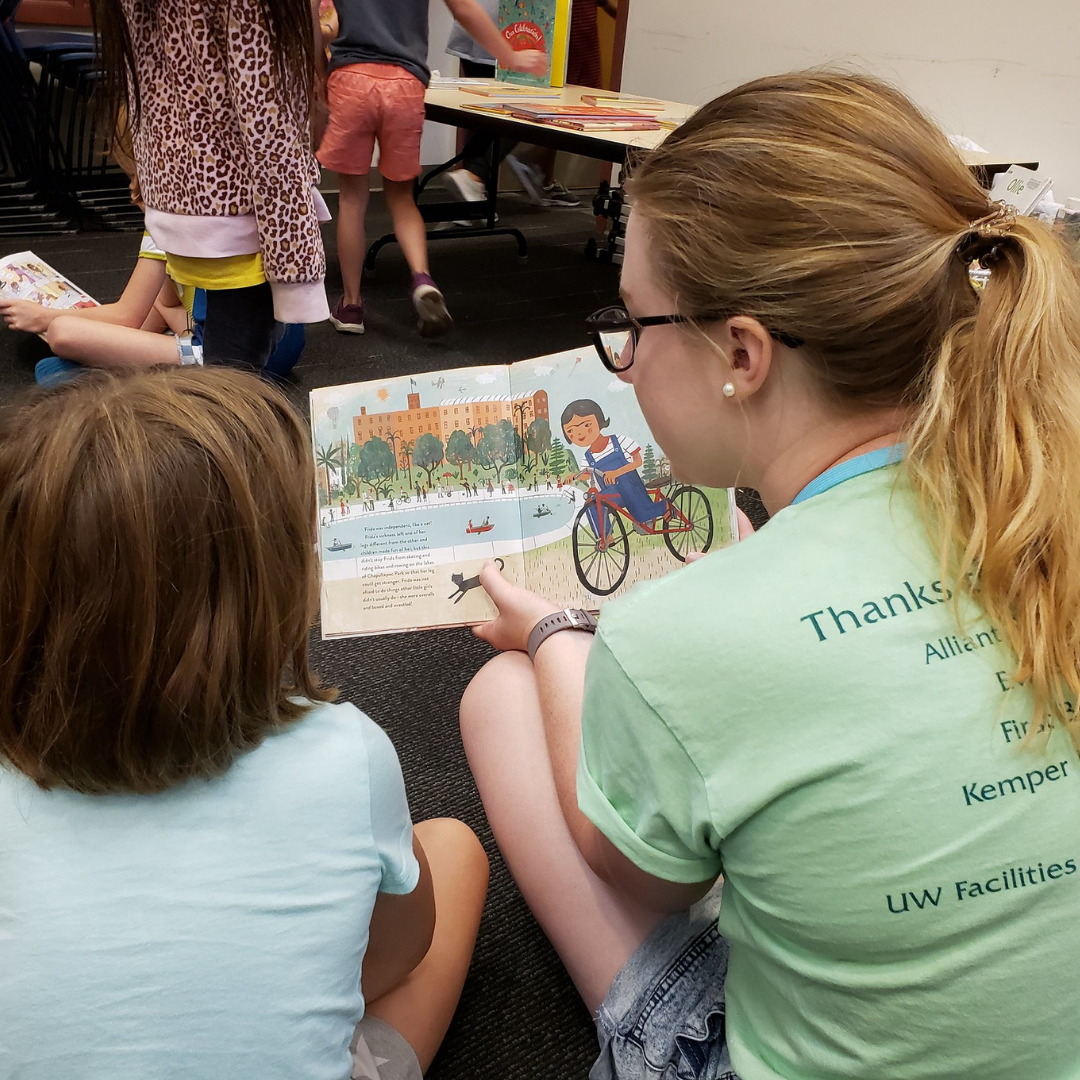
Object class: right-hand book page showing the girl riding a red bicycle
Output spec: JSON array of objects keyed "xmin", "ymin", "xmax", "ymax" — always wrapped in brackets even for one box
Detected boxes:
[{"xmin": 510, "ymin": 348, "xmax": 739, "ymax": 611}]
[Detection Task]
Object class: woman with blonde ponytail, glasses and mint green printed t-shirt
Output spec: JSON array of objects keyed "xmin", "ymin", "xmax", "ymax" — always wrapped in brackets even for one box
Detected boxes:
[{"xmin": 461, "ymin": 72, "xmax": 1080, "ymax": 1080}]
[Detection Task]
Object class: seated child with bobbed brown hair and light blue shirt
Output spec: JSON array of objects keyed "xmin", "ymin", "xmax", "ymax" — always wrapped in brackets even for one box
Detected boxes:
[{"xmin": 0, "ymin": 367, "xmax": 487, "ymax": 1080}]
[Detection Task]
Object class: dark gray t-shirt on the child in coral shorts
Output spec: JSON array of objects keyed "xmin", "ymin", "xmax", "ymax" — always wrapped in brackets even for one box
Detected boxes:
[{"xmin": 330, "ymin": 0, "xmax": 431, "ymax": 86}]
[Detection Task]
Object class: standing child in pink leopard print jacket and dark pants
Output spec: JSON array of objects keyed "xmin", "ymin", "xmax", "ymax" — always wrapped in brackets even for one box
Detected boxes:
[{"xmin": 93, "ymin": 0, "xmax": 329, "ymax": 368}]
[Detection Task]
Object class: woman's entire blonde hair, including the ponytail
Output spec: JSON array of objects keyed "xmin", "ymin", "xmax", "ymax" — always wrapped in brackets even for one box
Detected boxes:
[{"xmin": 629, "ymin": 71, "xmax": 1080, "ymax": 747}]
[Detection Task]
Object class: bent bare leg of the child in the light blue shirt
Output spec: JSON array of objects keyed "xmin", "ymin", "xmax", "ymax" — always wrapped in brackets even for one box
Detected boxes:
[{"xmin": 367, "ymin": 818, "xmax": 488, "ymax": 1072}]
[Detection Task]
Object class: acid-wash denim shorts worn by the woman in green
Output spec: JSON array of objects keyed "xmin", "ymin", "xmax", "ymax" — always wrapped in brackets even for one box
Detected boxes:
[{"xmin": 589, "ymin": 886, "xmax": 739, "ymax": 1080}]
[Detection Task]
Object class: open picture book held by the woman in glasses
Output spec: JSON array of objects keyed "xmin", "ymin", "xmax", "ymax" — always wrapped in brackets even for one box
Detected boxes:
[{"xmin": 310, "ymin": 348, "xmax": 738, "ymax": 637}]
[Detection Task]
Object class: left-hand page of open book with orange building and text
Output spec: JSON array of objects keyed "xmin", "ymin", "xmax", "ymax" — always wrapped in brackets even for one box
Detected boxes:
[{"xmin": 311, "ymin": 366, "xmax": 532, "ymax": 637}]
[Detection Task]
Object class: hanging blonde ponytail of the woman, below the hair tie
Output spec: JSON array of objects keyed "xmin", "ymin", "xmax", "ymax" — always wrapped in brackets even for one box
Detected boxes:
[{"xmin": 908, "ymin": 218, "xmax": 1080, "ymax": 746}]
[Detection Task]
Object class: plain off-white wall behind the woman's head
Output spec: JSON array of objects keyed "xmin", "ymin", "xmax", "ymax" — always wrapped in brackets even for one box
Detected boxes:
[{"xmin": 622, "ymin": 0, "xmax": 1080, "ymax": 202}]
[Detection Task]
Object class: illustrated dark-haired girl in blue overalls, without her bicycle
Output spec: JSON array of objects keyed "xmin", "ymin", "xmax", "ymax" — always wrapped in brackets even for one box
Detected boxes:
[{"xmin": 561, "ymin": 397, "xmax": 669, "ymax": 535}]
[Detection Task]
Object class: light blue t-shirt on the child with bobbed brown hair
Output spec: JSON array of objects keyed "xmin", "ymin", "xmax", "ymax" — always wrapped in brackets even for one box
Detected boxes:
[{"xmin": 0, "ymin": 704, "xmax": 420, "ymax": 1080}]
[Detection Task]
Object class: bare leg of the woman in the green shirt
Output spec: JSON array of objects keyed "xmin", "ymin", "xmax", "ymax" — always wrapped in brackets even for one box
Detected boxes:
[{"xmin": 461, "ymin": 652, "xmax": 663, "ymax": 1014}]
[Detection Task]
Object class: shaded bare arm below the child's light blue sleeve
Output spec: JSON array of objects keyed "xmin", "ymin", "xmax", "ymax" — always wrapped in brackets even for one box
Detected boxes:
[{"xmin": 361, "ymin": 832, "xmax": 435, "ymax": 1001}]
